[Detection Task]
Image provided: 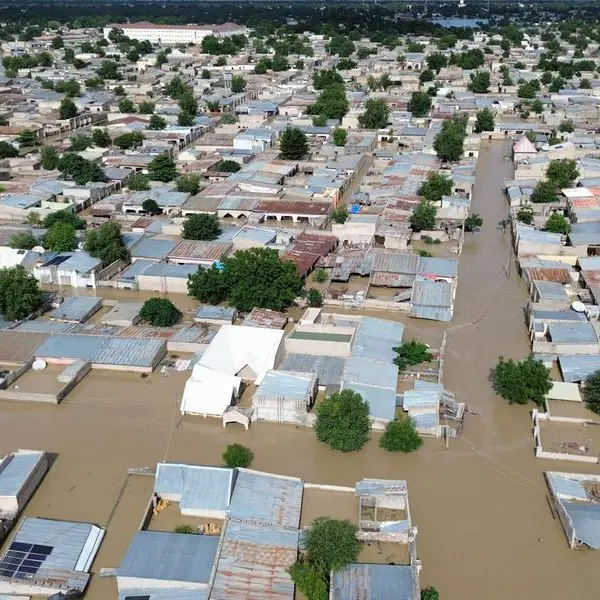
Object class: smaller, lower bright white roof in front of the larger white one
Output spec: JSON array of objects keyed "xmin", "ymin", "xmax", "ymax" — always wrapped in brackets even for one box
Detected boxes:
[{"xmin": 180, "ymin": 364, "xmax": 242, "ymax": 417}]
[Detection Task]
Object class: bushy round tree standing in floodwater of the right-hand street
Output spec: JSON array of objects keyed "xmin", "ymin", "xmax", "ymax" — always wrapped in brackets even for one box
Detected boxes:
[{"xmin": 492, "ymin": 356, "xmax": 552, "ymax": 405}]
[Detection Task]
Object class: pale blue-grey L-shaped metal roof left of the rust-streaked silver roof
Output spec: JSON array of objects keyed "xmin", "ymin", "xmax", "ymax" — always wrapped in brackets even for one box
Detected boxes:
[{"xmin": 154, "ymin": 463, "xmax": 233, "ymax": 511}]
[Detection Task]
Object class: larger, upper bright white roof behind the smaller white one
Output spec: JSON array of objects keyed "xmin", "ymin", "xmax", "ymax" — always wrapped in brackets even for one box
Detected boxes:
[{"xmin": 194, "ymin": 325, "xmax": 284, "ymax": 385}]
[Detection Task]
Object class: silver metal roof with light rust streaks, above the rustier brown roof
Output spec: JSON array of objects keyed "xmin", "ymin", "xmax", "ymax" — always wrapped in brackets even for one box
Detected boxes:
[{"xmin": 230, "ymin": 469, "xmax": 303, "ymax": 529}]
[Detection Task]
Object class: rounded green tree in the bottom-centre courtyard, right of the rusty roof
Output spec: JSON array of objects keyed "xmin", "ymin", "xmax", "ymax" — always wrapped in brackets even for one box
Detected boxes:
[{"xmin": 305, "ymin": 516, "xmax": 361, "ymax": 574}]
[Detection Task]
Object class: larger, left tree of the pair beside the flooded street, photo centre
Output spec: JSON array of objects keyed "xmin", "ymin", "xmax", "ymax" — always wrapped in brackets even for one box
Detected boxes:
[{"xmin": 315, "ymin": 389, "xmax": 371, "ymax": 452}]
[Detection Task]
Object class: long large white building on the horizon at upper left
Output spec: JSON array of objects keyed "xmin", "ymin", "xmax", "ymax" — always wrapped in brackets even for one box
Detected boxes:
[{"xmin": 103, "ymin": 22, "xmax": 246, "ymax": 45}]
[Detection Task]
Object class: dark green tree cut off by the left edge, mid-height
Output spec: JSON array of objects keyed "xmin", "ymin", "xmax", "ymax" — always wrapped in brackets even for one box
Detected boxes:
[{"xmin": 0, "ymin": 265, "xmax": 42, "ymax": 321}]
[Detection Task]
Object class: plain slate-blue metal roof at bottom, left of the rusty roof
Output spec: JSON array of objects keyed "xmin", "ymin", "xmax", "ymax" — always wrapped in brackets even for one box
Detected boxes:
[{"xmin": 118, "ymin": 531, "xmax": 219, "ymax": 584}]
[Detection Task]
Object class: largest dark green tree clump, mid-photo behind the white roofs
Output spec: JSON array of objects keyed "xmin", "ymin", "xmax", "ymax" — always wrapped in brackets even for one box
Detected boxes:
[{"xmin": 188, "ymin": 248, "xmax": 302, "ymax": 311}]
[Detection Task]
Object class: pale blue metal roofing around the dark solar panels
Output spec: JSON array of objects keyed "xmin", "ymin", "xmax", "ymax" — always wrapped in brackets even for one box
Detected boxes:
[{"xmin": 13, "ymin": 517, "xmax": 97, "ymax": 570}]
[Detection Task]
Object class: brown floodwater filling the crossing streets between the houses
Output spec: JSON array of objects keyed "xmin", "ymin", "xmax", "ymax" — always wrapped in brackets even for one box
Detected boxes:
[{"xmin": 0, "ymin": 143, "xmax": 600, "ymax": 600}]
